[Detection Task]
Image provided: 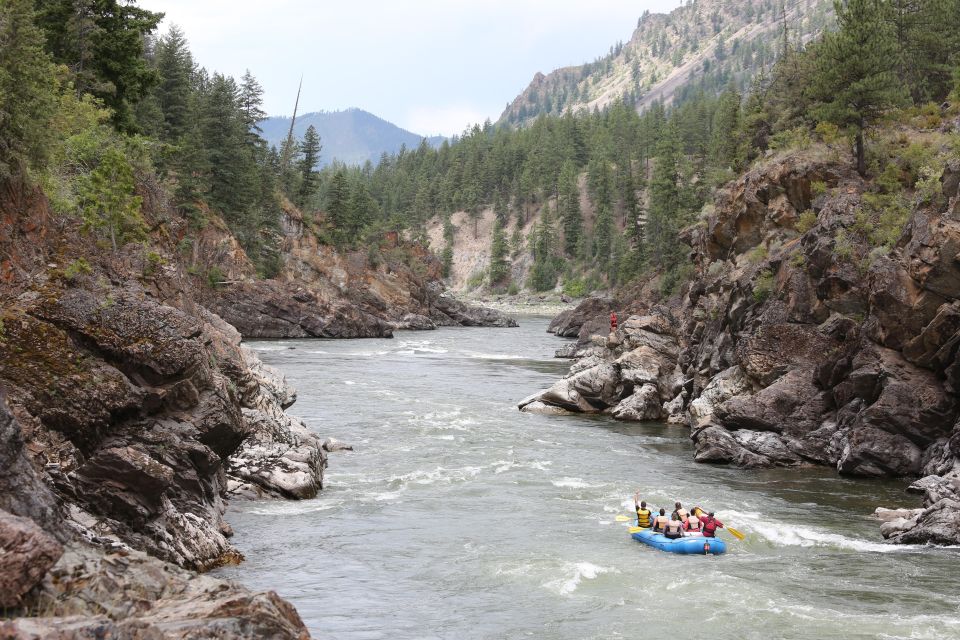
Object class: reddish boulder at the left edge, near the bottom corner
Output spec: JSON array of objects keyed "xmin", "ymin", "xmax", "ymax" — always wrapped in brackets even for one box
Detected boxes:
[{"xmin": 0, "ymin": 511, "xmax": 63, "ymax": 608}]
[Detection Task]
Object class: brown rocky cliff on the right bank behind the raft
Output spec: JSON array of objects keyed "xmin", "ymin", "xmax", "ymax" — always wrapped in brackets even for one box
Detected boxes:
[{"xmin": 521, "ymin": 119, "xmax": 960, "ymax": 544}]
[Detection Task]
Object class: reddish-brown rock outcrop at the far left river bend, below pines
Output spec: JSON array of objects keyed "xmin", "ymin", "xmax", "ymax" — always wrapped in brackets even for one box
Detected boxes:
[{"xmin": 199, "ymin": 209, "xmax": 516, "ymax": 338}]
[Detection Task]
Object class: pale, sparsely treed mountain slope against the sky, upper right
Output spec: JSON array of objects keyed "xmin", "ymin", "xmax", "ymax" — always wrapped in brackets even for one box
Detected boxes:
[{"xmin": 499, "ymin": 0, "xmax": 835, "ymax": 126}]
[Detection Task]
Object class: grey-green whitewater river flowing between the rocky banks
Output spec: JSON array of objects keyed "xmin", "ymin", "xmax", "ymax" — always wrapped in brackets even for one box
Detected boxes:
[{"xmin": 218, "ymin": 318, "xmax": 960, "ymax": 640}]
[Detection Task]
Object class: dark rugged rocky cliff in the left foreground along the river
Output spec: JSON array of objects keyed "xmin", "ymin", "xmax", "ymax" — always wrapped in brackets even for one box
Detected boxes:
[{"xmin": 0, "ymin": 186, "xmax": 326, "ymax": 638}]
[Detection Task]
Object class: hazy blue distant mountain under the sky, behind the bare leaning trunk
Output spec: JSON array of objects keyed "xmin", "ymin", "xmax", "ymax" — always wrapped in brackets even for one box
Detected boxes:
[{"xmin": 260, "ymin": 109, "xmax": 446, "ymax": 166}]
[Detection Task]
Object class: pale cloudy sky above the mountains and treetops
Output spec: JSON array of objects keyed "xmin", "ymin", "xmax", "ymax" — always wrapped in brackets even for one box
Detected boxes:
[{"xmin": 138, "ymin": 0, "xmax": 681, "ymax": 135}]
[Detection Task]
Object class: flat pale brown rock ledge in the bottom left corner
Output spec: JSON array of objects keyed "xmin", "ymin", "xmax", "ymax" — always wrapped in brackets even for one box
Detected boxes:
[{"xmin": 0, "ymin": 543, "xmax": 310, "ymax": 640}]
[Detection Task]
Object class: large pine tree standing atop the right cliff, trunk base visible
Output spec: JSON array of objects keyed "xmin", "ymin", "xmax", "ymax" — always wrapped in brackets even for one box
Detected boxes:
[{"xmin": 812, "ymin": 0, "xmax": 906, "ymax": 175}]
